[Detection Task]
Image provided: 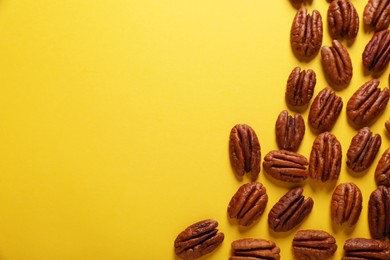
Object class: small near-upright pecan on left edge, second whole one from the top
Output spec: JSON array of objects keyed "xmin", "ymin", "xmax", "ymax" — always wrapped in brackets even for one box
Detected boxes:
[{"xmin": 286, "ymin": 67, "xmax": 316, "ymax": 107}]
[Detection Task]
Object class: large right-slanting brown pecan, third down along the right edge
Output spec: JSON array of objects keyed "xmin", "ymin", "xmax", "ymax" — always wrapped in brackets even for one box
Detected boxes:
[{"xmin": 347, "ymin": 79, "xmax": 390, "ymax": 128}]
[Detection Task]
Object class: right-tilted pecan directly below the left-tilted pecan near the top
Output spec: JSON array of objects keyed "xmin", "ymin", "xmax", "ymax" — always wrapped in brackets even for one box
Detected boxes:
[{"xmin": 309, "ymin": 87, "xmax": 343, "ymax": 133}]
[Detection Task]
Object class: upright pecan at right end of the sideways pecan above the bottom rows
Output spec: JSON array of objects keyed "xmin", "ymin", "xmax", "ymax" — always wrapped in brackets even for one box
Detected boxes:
[{"xmin": 309, "ymin": 132, "xmax": 342, "ymax": 182}]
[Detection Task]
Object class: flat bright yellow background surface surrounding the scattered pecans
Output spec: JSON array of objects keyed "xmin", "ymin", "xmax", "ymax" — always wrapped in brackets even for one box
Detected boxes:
[{"xmin": 0, "ymin": 0, "xmax": 390, "ymax": 260}]
